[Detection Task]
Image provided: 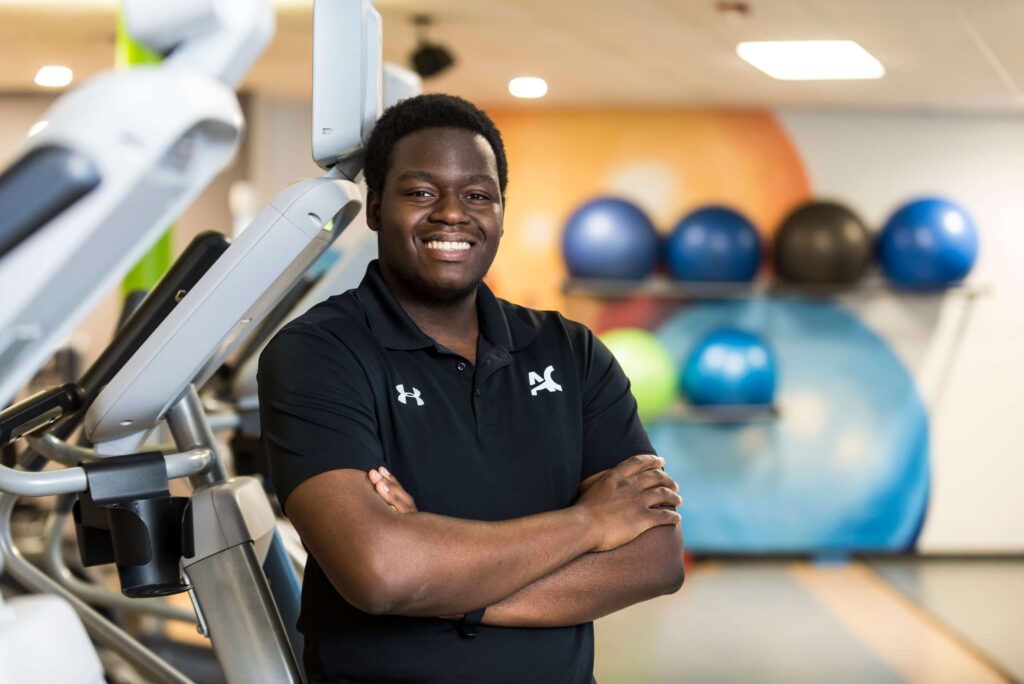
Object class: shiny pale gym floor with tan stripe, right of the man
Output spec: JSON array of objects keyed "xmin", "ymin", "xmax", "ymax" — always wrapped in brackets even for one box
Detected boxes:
[{"xmin": 595, "ymin": 557, "xmax": 1024, "ymax": 684}]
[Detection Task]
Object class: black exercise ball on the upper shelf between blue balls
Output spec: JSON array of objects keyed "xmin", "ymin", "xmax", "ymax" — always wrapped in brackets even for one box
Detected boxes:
[{"xmin": 774, "ymin": 202, "xmax": 873, "ymax": 285}]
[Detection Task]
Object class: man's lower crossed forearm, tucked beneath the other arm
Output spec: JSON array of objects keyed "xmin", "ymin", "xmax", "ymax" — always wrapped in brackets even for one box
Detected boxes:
[{"xmin": 483, "ymin": 525, "xmax": 683, "ymax": 628}]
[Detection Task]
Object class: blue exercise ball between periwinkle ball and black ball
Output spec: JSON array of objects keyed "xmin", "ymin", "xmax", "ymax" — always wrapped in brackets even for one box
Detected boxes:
[{"xmin": 666, "ymin": 207, "xmax": 761, "ymax": 283}]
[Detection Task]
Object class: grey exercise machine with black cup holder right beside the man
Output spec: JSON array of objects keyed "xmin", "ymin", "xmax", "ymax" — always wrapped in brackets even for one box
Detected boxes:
[{"xmin": 0, "ymin": 0, "xmax": 381, "ymax": 683}]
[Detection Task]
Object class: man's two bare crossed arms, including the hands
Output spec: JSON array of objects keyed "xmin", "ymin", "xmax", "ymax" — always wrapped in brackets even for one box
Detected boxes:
[{"xmin": 287, "ymin": 456, "xmax": 683, "ymax": 627}]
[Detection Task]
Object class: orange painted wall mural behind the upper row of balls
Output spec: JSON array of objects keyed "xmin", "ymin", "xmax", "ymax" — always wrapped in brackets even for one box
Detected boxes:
[{"xmin": 487, "ymin": 110, "xmax": 811, "ymax": 323}]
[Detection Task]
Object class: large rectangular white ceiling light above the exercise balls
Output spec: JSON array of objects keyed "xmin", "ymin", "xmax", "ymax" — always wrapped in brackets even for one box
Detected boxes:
[{"xmin": 736, "ymin": 40, "xmax": 886, "ymax": 81}]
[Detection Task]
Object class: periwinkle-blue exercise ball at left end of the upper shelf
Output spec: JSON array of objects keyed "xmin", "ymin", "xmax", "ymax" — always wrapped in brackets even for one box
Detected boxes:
[{"xmin": 562, "ymin": 198, "xmax": 658, "ymax": 281}]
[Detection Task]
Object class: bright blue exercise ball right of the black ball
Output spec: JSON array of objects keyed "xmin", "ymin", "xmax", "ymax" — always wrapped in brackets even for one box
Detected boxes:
[{"xmin": 879, "ymin": 198, "xmax": 978, "ymax": 288}]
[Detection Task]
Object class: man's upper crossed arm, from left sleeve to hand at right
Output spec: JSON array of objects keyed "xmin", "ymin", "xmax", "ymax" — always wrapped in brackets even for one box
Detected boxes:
[{"xmin": 285, "ymin": 455, "xmax": 680, "ymax": 616}]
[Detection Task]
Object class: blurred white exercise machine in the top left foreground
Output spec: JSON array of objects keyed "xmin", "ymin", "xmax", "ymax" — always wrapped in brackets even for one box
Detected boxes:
[{"xmin": 0, "ymin": 0, "xmax": 274, "ymax": 407}]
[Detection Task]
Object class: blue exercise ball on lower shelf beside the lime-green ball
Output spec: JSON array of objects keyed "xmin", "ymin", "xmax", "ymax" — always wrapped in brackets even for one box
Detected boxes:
[{"xmin": 681, "ymin": 328, "xmax": 776, "ymax": 405}]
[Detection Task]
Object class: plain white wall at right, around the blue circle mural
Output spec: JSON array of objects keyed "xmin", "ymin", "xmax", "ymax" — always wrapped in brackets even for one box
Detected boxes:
[{"xmin": 779, "ymin": 113, "xmax": 1024, "ymax": 553}]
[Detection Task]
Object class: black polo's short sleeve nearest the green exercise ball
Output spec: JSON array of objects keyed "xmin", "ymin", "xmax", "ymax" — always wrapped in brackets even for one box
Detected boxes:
[{"xmin": 581, "ymin": 329, "xmax": 654, "ymax": 479}]
